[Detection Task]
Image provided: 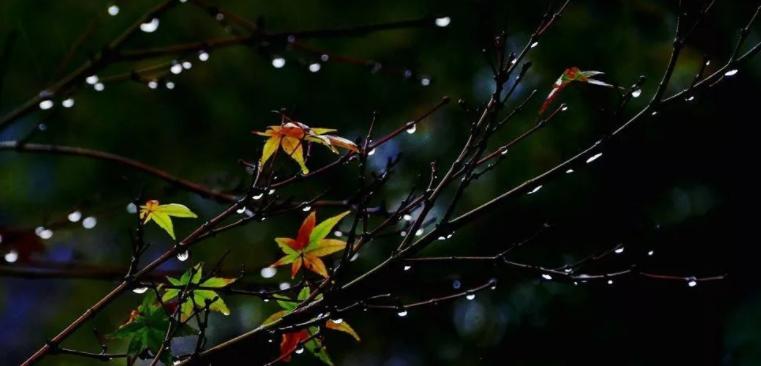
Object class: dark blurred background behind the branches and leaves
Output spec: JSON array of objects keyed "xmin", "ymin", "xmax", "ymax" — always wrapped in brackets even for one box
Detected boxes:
[{"xmin": 0, "ymin": 0, "xmax": 761, "ymax": 365}]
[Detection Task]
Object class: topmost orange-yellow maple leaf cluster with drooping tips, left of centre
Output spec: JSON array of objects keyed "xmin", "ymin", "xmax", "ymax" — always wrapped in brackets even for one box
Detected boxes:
[{"xmin": 253, "ymin": 115, "xmax": 359, "ymax": 174}]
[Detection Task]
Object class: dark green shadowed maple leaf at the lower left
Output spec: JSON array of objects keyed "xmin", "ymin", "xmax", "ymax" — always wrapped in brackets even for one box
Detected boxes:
[{"xmin": 110, "ymin": 292, "xmax": 196, "ymax": 365}]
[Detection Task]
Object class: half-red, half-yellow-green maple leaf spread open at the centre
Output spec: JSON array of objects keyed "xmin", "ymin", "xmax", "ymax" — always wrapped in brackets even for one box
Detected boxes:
[{"xmin": 272, "ymin": 211, "xmax": 350, "ymax": 278}]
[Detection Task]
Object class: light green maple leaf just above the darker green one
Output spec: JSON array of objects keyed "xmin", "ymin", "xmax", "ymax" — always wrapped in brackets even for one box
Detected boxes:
[{"xmin": 161, "ymin": 263, "xmax": 236, "ymax": 319}]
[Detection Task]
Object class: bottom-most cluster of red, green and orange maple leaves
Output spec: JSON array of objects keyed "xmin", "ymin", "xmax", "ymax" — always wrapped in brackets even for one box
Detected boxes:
[{"xmin": 264, "ymin": 286, "xmax": 360, "ymax": 365}]
